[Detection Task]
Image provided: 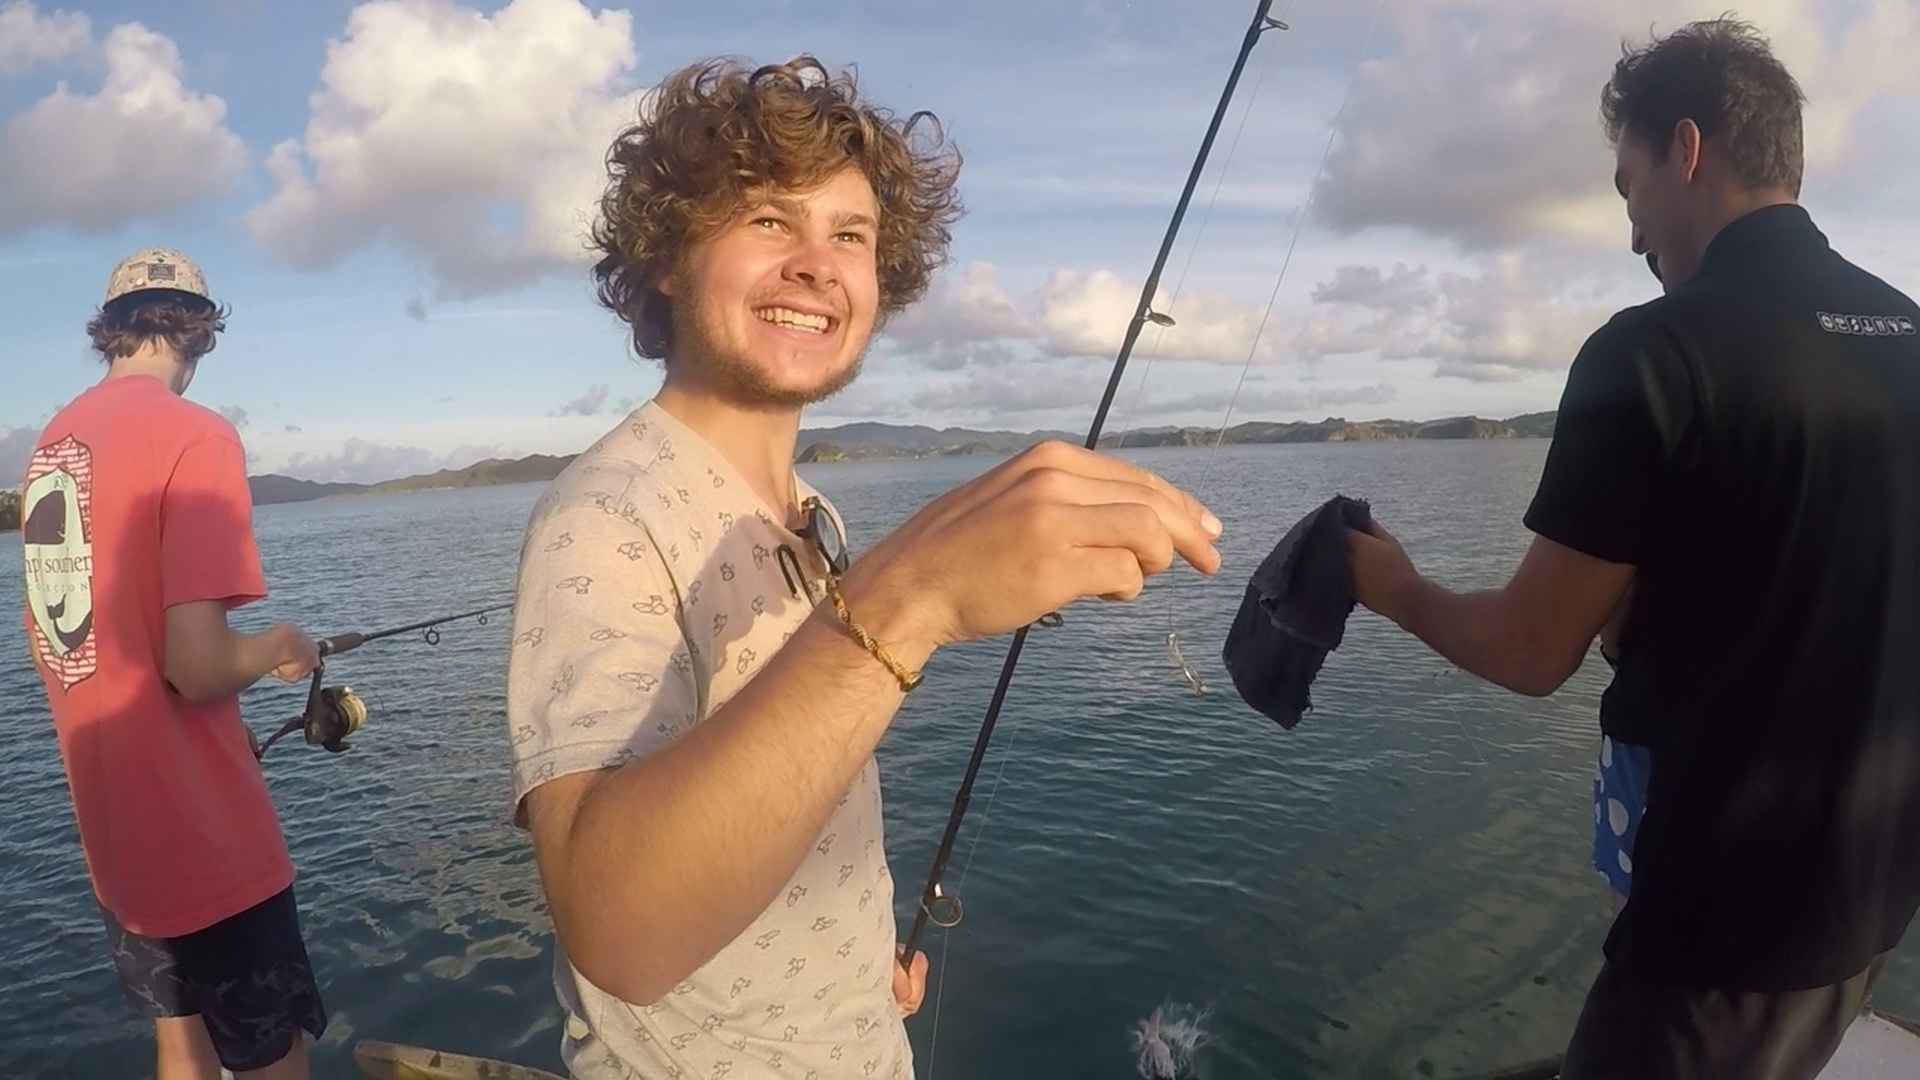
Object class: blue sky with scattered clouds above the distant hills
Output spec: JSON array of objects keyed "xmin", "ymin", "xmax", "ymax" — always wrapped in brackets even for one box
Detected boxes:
[{"xmin": 0, "ymin": 0, "xmax": 1920, "ymax": 480}]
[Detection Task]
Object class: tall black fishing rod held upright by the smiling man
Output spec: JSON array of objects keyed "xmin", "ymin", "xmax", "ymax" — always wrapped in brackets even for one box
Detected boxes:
[{"xmin": 900, "ymin": 0, "xmax": 1286, "ymax": 970}]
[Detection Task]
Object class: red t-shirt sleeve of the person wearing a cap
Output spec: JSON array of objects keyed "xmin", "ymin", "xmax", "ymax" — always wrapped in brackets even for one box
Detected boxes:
[{"xmin": 159, "ymin": 434, "xmax": 267, "ymax": 607}]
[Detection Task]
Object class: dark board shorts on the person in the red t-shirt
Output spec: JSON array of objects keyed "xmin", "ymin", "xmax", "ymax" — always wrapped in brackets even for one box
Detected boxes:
[{"xmin": 100, "ymin": 886, "xmax": 326, "ymax": 1072}]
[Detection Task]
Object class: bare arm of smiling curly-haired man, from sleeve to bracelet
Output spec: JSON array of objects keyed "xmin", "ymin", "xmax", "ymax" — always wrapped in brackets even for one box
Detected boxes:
[{"xmin": 536, "ymin": 588, "xmax": 925, "ymax": 1003}]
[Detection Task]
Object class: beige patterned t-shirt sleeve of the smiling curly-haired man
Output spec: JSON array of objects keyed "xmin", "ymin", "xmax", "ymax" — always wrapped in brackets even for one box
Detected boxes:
[{"xmin": 507, "ymin": 484, "xmax": 701, "ymax": 826}]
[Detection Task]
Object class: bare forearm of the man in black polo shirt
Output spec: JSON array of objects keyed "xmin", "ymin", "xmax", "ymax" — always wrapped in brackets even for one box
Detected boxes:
[{"xmin": 1386, "ymin": 578, "xmax": 1578, "ymax": 696}]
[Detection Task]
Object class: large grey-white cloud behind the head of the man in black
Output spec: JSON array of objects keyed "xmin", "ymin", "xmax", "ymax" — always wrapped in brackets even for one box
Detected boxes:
[{"xmin": 1315, "ymin": 0, "xmax": 1920, "ymax": 250}]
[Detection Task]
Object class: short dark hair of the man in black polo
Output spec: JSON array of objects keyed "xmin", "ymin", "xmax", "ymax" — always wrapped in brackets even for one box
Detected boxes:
[{"xmin": 1599, "ymin": 17, "xmax": 1807, "ymax": 198}]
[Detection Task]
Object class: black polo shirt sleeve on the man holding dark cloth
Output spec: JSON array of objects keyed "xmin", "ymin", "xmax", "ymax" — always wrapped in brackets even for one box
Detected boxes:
[{"xmin": 1524, "ymin": 317, "xmax": 1692, "ymax": 565}]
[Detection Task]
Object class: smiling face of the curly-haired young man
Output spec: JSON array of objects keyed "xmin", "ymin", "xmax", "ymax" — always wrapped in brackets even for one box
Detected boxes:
[{"xmin": 660, "ymin": 167, "xmax": 879, "ymax": 407}]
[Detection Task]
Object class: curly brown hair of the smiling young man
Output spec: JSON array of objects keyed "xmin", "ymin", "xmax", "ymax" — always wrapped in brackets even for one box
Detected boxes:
[{"xmin": 591, "ymin": 56, "xmax": 962, "ymax": 359}]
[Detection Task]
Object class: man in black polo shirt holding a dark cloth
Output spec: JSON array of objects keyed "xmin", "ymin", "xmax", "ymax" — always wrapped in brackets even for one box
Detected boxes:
[{"xmin": 1348, "ymin": 19, "xmax": 1920, "ymax": 1080}]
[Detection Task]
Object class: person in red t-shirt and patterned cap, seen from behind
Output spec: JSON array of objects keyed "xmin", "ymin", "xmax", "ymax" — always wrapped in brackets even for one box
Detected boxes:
[{"xmin": 21, "ymin": 248, "xmax": 326, "ymax": 1080}]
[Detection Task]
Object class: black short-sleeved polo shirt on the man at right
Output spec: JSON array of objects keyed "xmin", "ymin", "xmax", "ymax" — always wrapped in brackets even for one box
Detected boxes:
[{"xmin": 1526, "ymin": 206, "xmax": 1920, "ymax": 990}]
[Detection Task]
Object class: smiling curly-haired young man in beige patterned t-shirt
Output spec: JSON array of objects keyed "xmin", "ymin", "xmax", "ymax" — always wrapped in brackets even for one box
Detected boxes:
[{"xmin": 507, "ymin": 58, "xmax": 1219, "ymax": 1080}]
